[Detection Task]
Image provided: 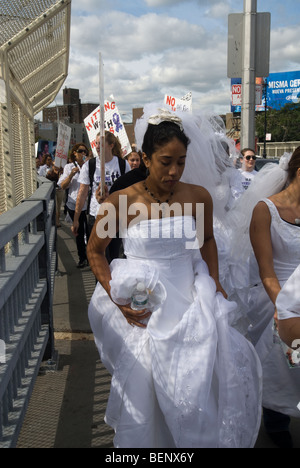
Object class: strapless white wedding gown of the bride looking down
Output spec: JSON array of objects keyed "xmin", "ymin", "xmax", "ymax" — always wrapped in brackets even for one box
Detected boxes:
[{"xmin": 89, "ymin": 216, "xmax": 261, "ymax": 448}]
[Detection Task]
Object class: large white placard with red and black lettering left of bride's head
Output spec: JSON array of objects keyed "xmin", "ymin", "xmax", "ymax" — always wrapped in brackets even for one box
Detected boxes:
[{"xmin": 84, "ymin": 101, "xmax": 132, "ymax": 157}]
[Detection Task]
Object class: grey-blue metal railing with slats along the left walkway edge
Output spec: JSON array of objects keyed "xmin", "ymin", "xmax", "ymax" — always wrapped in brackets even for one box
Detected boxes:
[{"xmin": 0, "ymin": 178, "xmax": 57, "ymax": 448}]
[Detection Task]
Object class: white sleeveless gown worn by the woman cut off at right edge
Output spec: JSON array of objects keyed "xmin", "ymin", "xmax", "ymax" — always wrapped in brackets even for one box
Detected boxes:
[{"xmin": 248, "ymin": 199, "xmax": 300, "ymax": 418}]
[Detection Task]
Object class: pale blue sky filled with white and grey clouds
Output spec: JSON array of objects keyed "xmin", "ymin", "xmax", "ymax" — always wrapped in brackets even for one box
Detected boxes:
[{"xmin": 52, "ymin": 0, "xmax": 300, "ymax": 121}]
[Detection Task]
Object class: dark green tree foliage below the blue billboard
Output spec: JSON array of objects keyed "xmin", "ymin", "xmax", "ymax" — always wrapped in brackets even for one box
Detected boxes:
[{"xmin": 256, "ymin": 103, "xmax": 300, "ymax": 142}]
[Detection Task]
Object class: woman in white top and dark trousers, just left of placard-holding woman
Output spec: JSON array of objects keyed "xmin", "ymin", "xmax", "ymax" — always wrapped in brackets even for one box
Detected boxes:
[{"xmin": 58, "ymin": 143, "xmax": 89, "ymax": 268}]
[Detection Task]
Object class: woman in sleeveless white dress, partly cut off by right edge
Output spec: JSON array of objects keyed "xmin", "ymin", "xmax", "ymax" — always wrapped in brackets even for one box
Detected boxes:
[{"xmin": 249, "ymin": 147, "xmax": 300, "ymax": 447}]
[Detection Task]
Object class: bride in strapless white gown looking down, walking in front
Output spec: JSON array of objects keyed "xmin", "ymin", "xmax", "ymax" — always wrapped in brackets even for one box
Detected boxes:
[{"xmin": 88, "ymin": 104, "xmax": 261, "ymax": 448}]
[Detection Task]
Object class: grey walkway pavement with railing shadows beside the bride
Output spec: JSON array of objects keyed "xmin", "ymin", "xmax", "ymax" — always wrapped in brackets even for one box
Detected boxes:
[{"xmin": 17, "ymin": 221, "xmax": 300, "ymax": 448}]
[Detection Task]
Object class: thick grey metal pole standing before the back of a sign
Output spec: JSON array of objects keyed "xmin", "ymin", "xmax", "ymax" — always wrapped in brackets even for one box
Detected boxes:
[{"xmin": 241, "ymin": 0, "xmax": 257, "ymax": 150}]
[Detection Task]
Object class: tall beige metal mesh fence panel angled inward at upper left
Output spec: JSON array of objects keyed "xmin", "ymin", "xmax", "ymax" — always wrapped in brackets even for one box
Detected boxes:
[{"xmin": 0, "ymin": 0, "xmax": 71, "ymax": 214}]
